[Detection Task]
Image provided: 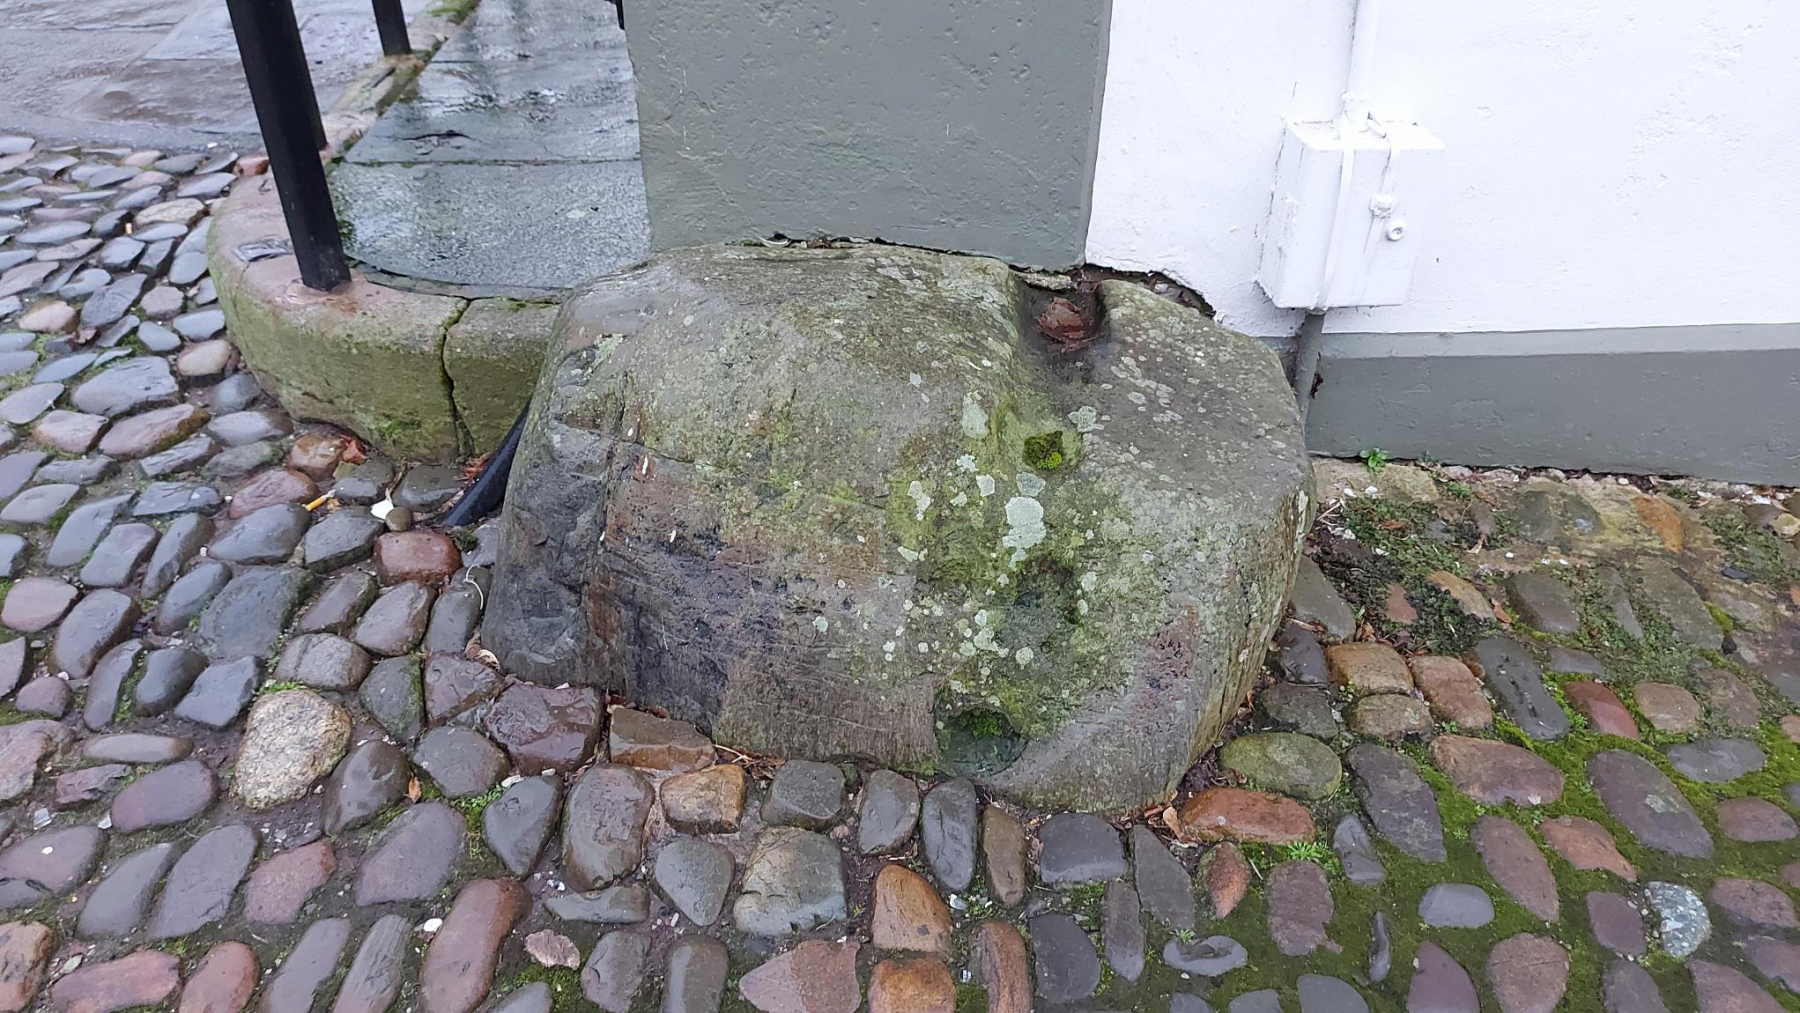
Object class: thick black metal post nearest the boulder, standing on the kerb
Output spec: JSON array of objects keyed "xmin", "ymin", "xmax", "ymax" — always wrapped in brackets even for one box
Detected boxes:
[{"xmin": 225, "ymin": 0, "xmax": 349, "ymax": 290}]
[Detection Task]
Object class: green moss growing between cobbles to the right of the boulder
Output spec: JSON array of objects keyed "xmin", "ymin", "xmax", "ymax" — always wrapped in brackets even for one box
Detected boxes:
[{"xmin": 1199, "ymin": 554, "xmax": 1800, "ymax": 1013}]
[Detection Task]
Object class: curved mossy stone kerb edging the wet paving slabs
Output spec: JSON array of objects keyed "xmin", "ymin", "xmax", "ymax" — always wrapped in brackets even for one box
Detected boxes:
[{"xmin": 207, "ymin": 0, "xmax": 556, "ymax": 461}]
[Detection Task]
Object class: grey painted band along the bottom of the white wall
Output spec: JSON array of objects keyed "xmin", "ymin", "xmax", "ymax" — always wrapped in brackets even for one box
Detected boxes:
[{"xmin": 1307, "ymin": 324, "xmax": 1800, "ymax": 486}]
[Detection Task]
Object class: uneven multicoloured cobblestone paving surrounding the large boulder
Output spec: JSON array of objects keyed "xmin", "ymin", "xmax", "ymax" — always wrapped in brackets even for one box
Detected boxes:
[{"xmin": 0, "ymin": 137, "xmax": 1800, "ymax": 1013}]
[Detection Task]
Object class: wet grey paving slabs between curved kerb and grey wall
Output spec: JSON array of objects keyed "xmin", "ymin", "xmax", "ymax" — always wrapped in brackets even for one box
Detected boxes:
[{"xmin": 331, "ymin": 0, "xmax": 650, "ymax": 297}]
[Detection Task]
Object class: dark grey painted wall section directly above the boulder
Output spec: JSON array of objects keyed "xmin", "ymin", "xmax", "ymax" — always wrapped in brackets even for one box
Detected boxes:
[{"xmin": 625, "ymin": 0, "xmax": 1112, "ymax": 268}]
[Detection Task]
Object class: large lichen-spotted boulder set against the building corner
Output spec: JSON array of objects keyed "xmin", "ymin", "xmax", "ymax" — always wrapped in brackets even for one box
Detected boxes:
[{"xmin": 486, "ymin": 247, "xmax": 1310, "ymax": 810}]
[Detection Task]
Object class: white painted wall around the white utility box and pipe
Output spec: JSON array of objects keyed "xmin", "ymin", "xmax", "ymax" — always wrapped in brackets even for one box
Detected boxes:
[{"xmin": 1087, "ymin": 0, "xmax": 1800, "ymax": 336}]
